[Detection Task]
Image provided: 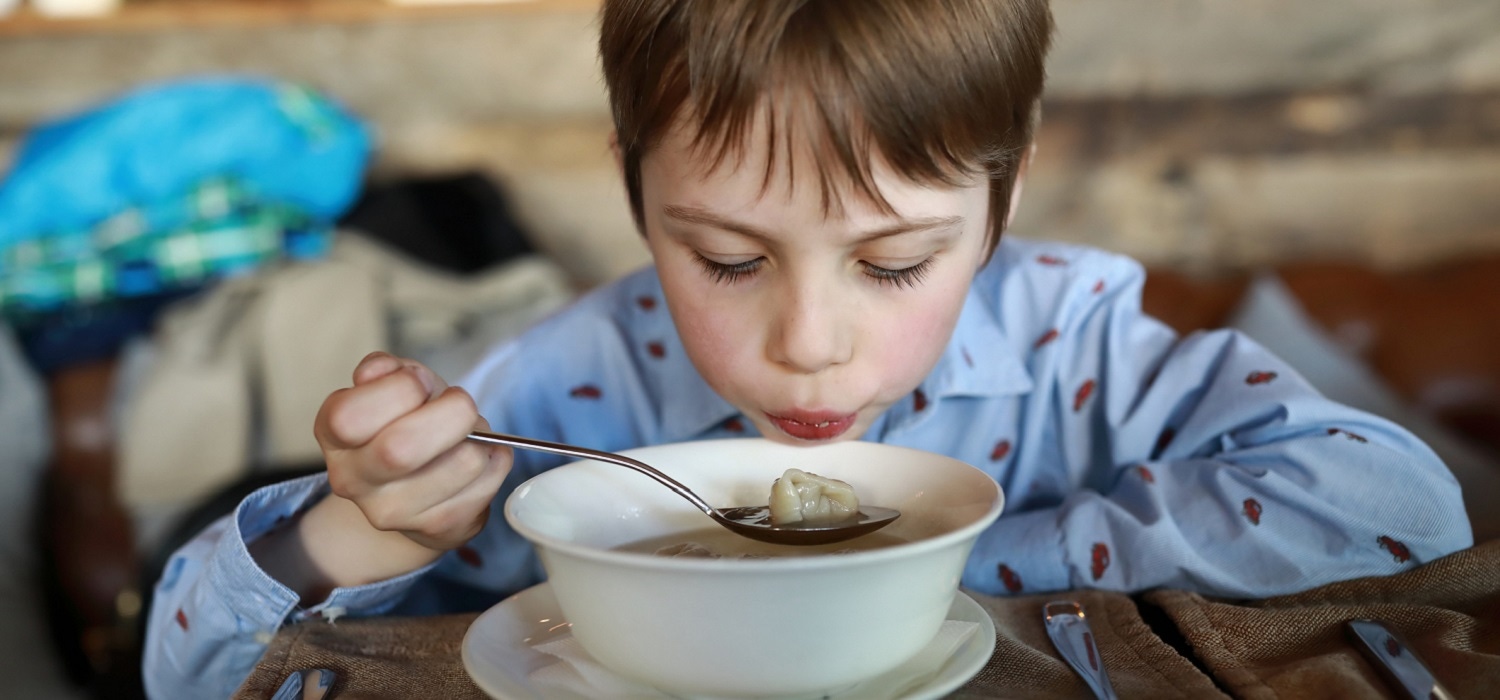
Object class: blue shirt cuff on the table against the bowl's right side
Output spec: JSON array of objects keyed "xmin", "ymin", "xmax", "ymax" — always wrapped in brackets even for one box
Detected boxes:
[{"xmin": 963, "ymin": 508, "xmax": 1071, "ymax": 595}]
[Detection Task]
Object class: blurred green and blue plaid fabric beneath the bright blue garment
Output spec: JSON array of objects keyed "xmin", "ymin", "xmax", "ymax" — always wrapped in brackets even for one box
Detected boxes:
[{"xmin": 0, "ymin": 180, "xmax": 332, "ymax": 319}]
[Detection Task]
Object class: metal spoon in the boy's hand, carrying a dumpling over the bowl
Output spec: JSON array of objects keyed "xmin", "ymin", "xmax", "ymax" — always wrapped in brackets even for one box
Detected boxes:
[{"xmin": 468, "ymin": 430, "xmax": 902, "ymax": 544}]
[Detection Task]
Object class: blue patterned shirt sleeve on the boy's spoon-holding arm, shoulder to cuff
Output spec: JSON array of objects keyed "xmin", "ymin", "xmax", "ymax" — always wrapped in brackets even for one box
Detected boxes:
[{"xmin": 144, "ymin": 271, "xmax": 686, "ymax": 699}]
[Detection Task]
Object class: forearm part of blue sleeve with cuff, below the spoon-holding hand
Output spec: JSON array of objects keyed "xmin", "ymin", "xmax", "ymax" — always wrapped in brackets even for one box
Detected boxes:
[{"xmin": 143, "ymin": 474, "xmax": 434, "ymax": 699}]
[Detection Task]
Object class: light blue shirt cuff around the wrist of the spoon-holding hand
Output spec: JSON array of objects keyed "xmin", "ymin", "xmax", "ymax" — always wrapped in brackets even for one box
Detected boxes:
[{"xmin": 207, "ymin": 474, "xmax": 437, "ymax": 631}]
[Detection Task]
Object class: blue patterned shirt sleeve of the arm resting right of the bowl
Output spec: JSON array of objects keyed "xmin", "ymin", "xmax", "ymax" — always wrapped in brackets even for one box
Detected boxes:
[{"xmin": 965, "ymin": 254, "xmax": 1473, "ymax": 598}]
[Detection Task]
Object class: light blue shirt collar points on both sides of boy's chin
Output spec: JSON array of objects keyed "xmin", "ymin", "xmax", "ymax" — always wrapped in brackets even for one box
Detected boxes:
[{"xmin": 651, "ymin": 274, "xmax": 1032, "ymax": 442}]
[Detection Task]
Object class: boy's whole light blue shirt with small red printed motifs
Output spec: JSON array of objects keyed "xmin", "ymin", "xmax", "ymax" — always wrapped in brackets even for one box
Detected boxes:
[{"xmin": 146, "ymin": 238, "xmax": 1473, "ymax": 699}]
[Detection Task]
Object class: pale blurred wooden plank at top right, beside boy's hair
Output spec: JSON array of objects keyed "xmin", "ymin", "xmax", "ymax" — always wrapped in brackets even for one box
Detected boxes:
[{"xmin": 1047, "ymin": 0, "xmax": 1500, "ymax": 97}]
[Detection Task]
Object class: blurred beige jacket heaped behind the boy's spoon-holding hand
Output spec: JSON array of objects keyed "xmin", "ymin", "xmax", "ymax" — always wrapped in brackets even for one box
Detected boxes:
[{"xmin": 119, "ymin": 234, "xmax": 573, "ymax": 511}]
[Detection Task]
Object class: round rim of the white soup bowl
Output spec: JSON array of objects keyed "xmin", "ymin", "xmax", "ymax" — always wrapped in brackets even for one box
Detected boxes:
[{"xmin": 504, "ymin": 438, "xmax": 1005, "ymax": 574}]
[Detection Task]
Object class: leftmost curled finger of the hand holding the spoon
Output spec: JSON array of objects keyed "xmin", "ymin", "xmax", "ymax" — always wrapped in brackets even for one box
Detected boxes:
[{"xmin": 314, "ymin": 369, "xmax": 429, "ymax": 450}]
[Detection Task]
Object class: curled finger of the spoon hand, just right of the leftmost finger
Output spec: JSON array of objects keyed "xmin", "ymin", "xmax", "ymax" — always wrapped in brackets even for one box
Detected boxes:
[{"xmin": 369, "ymin": 388, "xmax": 479, "ymax": 481}]
